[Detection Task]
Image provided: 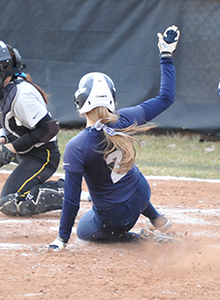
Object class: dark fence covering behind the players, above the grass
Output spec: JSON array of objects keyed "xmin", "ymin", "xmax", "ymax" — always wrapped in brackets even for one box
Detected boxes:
[{"xmin": 0, "ymin": 0, "xmax": 220, "ymax": 136}]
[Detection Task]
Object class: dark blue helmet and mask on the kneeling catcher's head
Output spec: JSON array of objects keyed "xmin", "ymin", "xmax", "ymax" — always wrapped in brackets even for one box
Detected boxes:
[{"xmin": 0, "ymin": 41, "xmax": 25, "ymax": 89}]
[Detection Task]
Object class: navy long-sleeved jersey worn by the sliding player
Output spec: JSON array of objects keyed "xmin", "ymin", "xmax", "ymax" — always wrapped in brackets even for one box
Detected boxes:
[{"xmin": 59, "ymin": 58, "xmax": 175, "ymax": 238}]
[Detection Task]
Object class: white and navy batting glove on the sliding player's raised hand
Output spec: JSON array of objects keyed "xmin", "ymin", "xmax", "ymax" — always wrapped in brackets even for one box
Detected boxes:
[{"xmin": 157, "ymin": 25, "xmax": 180, "ymax": 58}]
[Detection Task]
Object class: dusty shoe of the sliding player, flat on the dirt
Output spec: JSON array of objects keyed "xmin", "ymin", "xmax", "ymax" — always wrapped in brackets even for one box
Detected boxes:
[{"xmin": 140, "ymin": 228, "xmax": 179, "ymax": 244}]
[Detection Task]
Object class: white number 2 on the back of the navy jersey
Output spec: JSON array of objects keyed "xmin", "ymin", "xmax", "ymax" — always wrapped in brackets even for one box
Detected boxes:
[{"xmin": 106, "ymin": 150, "xmax": 126, "ymax": 183}]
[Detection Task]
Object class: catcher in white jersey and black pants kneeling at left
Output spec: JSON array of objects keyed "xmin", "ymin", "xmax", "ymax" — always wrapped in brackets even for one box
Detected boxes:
[{"xmin": 0, "ymin": 41, "xmax": 64, "ymax": 216}]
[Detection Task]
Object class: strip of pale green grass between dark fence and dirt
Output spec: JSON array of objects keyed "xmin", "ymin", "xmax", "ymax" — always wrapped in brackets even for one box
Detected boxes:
[{"xmin": 2, "ymin": 129, "xmax": 220, "ymax": 179}]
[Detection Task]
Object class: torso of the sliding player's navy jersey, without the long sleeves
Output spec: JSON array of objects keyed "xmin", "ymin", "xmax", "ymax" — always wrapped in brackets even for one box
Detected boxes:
[{"xmin": 64, "ymin": 127, "xmax": 140, "ymax": 208}]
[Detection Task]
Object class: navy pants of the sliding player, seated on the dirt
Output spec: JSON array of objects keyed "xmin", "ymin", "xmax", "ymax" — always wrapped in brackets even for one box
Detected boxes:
[{"xmin": 77, "ymin": 177, "xmax": 150, "ymax": 240}]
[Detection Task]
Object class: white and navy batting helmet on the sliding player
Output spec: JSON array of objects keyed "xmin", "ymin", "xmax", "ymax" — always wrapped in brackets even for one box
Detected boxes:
[{"xmin": 74, "ymin": 72, "xmax": 116, "ymax": 114}]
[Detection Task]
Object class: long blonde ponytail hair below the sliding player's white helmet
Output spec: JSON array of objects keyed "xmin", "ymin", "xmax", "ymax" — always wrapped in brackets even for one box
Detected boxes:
[{"xmin": 86, "ymin": 106, "xmax": 155, "ymax": 174}]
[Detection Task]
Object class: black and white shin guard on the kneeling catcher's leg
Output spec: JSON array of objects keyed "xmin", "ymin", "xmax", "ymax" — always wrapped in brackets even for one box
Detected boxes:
[{"xmin": 0, "ymin": 179, "xmax": 64, "ymax": 216}]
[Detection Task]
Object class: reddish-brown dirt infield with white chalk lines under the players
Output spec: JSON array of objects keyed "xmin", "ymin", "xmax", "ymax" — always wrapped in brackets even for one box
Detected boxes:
[{"xmin": 0, "ymin": 174, "xmax": 220, "ymax": 300}]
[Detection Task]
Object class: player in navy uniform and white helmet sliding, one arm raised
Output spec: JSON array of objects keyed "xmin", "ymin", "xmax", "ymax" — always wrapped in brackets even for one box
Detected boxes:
[{"xmin": 49, "ymin": 26, "xmax": 180, "ymax": 250}]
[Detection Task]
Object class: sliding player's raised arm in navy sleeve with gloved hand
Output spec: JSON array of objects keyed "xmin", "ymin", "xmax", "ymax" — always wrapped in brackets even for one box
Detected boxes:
[{"xmin": 118, "ymin": 26, "xmax": 180, "ymax": 128}]
